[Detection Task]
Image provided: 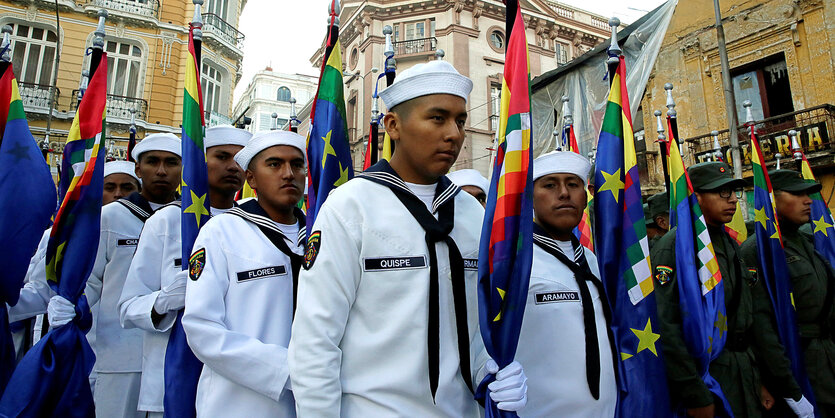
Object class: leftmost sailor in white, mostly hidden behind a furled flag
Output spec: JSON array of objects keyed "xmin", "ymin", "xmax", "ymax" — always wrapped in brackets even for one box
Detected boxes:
[{"xmin": 9, "ymin": 161, "xmax": 140, "ymax": 386}]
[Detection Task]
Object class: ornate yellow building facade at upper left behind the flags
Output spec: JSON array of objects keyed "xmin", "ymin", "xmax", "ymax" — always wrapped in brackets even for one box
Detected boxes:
[{"xmin": 0, "ymin": 0, "xmax": 246, "ymax": 171}]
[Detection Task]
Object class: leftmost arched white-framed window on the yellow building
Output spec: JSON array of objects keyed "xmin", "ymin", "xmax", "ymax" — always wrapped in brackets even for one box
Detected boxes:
[{"xmin": 11, "ymin": 24, "xmax": 58, "ymax": 85}]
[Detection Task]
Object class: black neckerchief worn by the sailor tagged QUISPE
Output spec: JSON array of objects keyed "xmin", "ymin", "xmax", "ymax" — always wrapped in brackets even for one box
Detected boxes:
[{"xmin": 358, "ymin": 160, "xmax": 473, "ymax": 400}]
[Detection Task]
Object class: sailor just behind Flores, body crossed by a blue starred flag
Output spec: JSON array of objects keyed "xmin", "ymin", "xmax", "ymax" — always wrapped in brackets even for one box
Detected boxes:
[{"xmin": 119, "ymin": 125, "xmax": 252, "ymax": 417}]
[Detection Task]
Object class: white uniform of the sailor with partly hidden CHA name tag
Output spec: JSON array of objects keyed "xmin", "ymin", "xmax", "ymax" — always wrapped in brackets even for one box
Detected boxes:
[{"xmin": 86, "ymin": 193, "xmax": 168, "ymax": 417}]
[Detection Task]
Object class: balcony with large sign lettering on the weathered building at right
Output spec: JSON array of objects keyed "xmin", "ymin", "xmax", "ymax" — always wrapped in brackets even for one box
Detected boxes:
[{"xmin": 682, "ymin": 104, "xmax": 835, "ymax": 170}]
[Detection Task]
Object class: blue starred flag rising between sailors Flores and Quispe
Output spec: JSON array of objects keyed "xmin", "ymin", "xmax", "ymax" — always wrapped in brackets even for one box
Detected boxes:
[{"xmin": 307, "ymin": 18, "xmax": 354, "ymax": 235}]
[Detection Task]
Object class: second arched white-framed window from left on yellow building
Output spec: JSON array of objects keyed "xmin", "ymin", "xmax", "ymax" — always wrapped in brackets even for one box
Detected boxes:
[{"xmin": 104, "ymin": 41, "xmax": 142, "ymax": 98}]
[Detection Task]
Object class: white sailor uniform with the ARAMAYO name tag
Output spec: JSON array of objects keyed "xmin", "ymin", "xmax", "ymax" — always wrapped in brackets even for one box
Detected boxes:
[{"xmin": 516, "ymin": 225, "xmax": 617, "ymax": 418}]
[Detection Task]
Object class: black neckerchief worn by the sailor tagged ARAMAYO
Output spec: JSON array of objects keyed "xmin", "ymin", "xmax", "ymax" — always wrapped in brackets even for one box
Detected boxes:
[{"xmin": 533, "ymin": 224, "xmax": 617, "ymax": 400}]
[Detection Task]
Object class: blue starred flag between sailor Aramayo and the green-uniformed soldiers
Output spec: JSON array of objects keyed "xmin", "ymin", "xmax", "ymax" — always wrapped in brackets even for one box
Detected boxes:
[{"xmin": 594, "ymin": 57, "xmax": 672, "ymax": 417}]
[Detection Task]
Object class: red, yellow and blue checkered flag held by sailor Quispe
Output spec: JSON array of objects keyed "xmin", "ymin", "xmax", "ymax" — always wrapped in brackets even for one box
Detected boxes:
[{"xmin": 477, "ymin": 0, "xmax": 533, "ymax": 418}]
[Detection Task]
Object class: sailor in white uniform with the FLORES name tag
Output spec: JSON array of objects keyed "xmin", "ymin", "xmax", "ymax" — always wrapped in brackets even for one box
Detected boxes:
[{"xmin": 183, "ymin": 131, "xmax": 307, "ymax": 418}]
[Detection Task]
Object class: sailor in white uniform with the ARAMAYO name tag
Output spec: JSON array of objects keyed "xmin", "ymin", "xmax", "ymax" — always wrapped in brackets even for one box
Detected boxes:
[{"xmin": 516, "ymin": 151, "xmax": 617, "ymax": 418}]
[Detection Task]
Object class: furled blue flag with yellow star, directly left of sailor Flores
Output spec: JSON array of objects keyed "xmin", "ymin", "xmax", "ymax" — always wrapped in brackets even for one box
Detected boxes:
[{"xmin": 163, "ymin": 26, "xmax": 210, "ymax": 418}]
